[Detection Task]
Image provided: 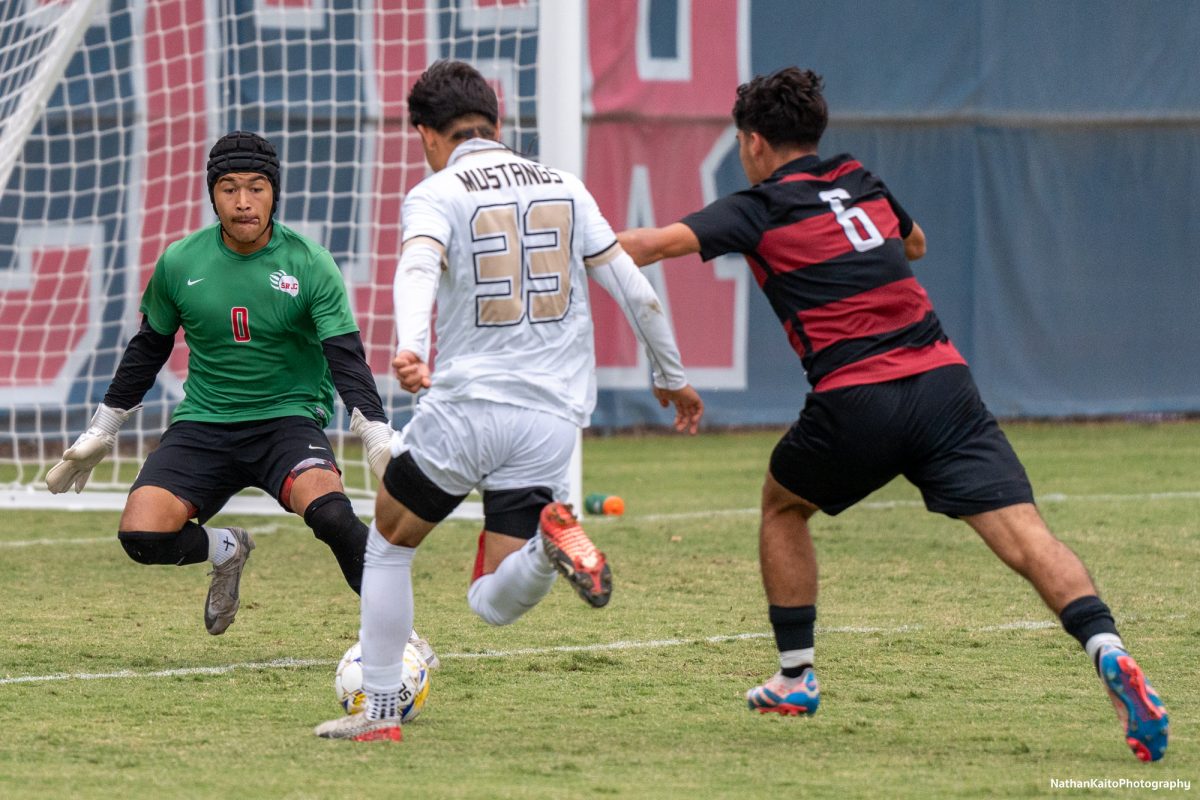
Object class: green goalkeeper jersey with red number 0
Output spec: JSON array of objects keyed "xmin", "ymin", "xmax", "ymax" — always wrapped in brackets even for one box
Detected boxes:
[{"xmin": 142, "ymin": 223, "xmax": 359, "ymax": 426}]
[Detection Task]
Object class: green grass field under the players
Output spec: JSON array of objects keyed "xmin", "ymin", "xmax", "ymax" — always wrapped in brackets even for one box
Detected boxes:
[{"xmin": 0, "ymin": 422, "xmax": 1200, "ymax": 800}]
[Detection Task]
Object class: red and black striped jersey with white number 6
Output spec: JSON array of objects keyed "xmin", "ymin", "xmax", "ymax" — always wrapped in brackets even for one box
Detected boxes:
[{"xmin": 683, "ymin": 154, "xmax": 966, "ymax": 391}]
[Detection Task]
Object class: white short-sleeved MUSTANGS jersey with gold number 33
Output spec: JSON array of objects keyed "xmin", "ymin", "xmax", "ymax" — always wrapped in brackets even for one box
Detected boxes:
[{"xmin": 397, "ymin": 139, "xmax": 619, "ymax": 426}]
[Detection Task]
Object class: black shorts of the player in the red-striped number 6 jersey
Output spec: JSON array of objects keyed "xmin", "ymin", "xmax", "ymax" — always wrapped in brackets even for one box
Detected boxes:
[{"xmin": 770, "ymin": 366, "xmax": 1033, "ymax": 517}]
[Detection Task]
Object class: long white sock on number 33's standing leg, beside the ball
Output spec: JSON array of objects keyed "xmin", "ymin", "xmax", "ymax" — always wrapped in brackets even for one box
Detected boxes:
[{"xmin": 359, "ymin": 522, "xmax": 416, "ymax": 720}]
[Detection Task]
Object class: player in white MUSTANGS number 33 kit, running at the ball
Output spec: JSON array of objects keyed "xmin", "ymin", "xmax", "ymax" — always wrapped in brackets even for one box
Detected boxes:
[{"xmin": 316, "ymin": 61, "xmax": 704, "ymax": 741}]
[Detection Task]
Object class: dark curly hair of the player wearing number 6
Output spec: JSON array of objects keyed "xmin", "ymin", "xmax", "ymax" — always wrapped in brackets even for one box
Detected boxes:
[{"xmin": 733, "ymin": 67, "xmax": 829, "ymax": 148}]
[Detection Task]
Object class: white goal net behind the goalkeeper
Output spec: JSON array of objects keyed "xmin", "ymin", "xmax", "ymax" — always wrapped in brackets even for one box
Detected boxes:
[{"xmin": 0, "ymin": 0, "xmax": 580, "ymax": 511}]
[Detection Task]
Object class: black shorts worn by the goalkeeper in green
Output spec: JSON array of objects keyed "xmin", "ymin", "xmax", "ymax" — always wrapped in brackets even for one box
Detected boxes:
[{"xmin": 130, "ymin": 416, "xmax": 337, "ymax": 523}]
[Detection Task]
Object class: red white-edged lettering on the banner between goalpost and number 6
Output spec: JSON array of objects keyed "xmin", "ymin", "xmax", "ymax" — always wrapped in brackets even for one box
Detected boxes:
[{"xmin": 584, "ymin": 0, "xmax": 748, "ymax": 389}]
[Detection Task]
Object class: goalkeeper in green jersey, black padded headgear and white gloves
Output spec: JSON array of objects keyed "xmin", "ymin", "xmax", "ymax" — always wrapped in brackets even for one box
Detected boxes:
[{"xmin": 46, "ymin": 131, "xmax": 436, "ymax": 662}]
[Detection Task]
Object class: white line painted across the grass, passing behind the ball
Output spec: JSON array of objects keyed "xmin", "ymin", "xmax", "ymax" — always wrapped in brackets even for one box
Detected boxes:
[{"xmin": 0, "ymin": 614, "xmax": 1187, "ymax": 686}]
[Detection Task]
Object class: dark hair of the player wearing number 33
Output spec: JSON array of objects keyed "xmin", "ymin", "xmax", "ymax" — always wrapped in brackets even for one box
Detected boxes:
[{"xmin": 408, "ymin": 59, "xmax": 500, "ymax": 140}]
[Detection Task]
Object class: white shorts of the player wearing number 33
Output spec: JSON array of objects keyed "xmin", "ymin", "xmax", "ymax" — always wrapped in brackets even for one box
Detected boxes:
[{"xmin": 394, "ymin": 401, "xmax": 578, "ymax": 501}]
